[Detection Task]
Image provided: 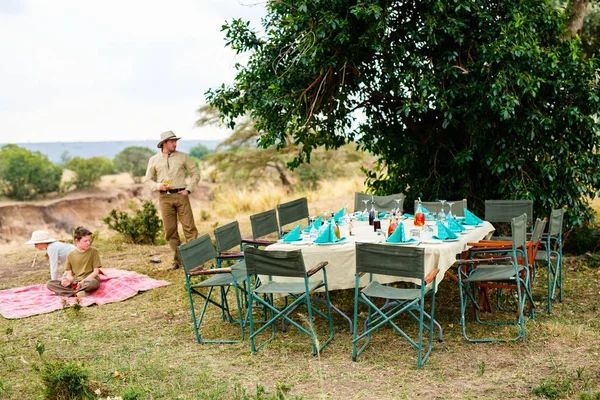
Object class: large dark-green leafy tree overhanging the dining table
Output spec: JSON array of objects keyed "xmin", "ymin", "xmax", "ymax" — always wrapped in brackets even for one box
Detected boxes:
[{"xmin": 206, "ymin": 0, "xmax": 600, "ymax": 224}]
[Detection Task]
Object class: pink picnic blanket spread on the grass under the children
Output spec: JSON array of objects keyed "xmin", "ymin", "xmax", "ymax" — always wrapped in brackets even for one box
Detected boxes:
[{"xmin": 0, "ymin": 268, "xmax": 171, "ymax": 319}]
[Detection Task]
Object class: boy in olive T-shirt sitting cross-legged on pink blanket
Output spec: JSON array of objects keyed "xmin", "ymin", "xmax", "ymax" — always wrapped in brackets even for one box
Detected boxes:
[{"xmin": 46, "ymin": 226, "xmax": 101, "ymax": 297}]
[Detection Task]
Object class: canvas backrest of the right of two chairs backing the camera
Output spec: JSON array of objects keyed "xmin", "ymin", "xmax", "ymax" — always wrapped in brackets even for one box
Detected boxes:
[{"xmin": 356, "ymin": 242, "xmax": 425, "ymax": 279}]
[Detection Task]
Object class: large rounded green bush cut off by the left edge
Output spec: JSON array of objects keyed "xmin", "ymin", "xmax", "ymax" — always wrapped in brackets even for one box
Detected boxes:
[{"xmin": 0, "ymin": 144, "xmax": 62, "ymax": 200}]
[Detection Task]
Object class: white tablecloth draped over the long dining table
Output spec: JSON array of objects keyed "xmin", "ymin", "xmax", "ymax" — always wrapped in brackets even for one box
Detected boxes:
[{"xmin": 261, "ymin": 220, "xmax": 494, "ymax": 290}]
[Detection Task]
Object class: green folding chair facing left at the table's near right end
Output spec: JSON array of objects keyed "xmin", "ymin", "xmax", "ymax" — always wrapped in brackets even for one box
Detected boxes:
[{"xmin": 456, "ymin": 214, "xmax": 534, "ymax": 342}]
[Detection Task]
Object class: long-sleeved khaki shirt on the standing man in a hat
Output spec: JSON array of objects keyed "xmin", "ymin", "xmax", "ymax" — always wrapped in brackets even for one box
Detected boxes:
[{"xmin": 142, "ymin": 151, "xmax": 200, "ymax": 193}]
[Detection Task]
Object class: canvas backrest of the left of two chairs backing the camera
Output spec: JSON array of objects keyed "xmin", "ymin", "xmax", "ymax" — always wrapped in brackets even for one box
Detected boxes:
[{"xmin": 244, "ymin": 246, "xmax": 306, "ymax": 278}]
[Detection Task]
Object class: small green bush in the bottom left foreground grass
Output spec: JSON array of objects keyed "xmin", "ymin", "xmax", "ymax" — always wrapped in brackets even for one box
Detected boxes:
[{"xmin": 41, "ymin": 361, "xmax": 93, "ymax": 400}]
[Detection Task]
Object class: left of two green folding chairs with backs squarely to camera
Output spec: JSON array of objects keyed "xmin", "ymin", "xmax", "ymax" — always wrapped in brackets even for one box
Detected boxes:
[{"xmin": 244, "ymin": 247, "xmax": 333, "ymax": 355}]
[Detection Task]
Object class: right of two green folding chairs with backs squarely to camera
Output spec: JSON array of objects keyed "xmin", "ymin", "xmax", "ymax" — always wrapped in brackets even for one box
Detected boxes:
[{"xmin": 352, "ymin": 243, "xmax": 439, "ymax": 368}]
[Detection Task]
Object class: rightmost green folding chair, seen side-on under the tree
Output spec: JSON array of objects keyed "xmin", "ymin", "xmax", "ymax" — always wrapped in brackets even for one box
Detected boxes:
[{"xmin": 535, "ymin": 208, "xmax": 566, "ymax": 313}]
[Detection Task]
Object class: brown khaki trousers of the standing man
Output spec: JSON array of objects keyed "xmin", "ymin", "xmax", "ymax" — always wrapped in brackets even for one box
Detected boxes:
[{"xmin": 159, "ymin": 193, "xmax": 198, "ymax": 264}]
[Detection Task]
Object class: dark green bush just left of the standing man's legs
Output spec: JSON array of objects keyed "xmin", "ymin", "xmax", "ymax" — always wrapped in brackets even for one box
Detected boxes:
[{"xmin": 102, "ymin": 200, "xmax": 162, "ymax": 244}]
